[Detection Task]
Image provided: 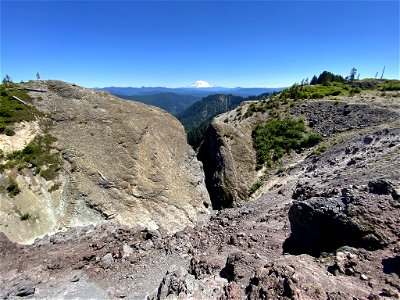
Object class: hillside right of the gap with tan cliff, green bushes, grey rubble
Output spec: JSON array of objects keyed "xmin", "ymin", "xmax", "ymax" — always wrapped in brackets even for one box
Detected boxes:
[{"xmin": 199, "ymin": 81, "xmax": 398, "ymax": 207}]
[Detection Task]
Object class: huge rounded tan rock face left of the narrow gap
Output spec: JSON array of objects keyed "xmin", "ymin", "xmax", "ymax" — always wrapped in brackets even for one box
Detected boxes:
[{"xmin": 0, "ymin": 81, "xmax": 211, "ymax": 242}]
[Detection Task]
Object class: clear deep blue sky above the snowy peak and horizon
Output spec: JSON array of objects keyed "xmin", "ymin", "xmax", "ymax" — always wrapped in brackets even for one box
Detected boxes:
[{"xmin": 0, "ymin": 0, "xmax": 399, "ymax": 87}]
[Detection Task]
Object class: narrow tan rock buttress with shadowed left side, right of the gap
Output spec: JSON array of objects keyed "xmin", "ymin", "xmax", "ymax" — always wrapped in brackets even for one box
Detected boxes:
[{"xmin": 198, "ymin": 106, "xmax": 257, "ymax": 209}]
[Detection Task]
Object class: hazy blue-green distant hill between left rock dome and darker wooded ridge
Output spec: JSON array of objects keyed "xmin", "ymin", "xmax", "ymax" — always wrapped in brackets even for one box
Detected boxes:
[{"xmin": 116, "ymin": 92, "xmax": 201, "ymax": 115}]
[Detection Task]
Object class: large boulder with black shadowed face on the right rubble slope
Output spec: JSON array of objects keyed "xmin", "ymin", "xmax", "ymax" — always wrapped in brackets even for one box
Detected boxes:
[{"xmin": 283, "ymin": 197, "xmax": 386, "ymax": 256}]
